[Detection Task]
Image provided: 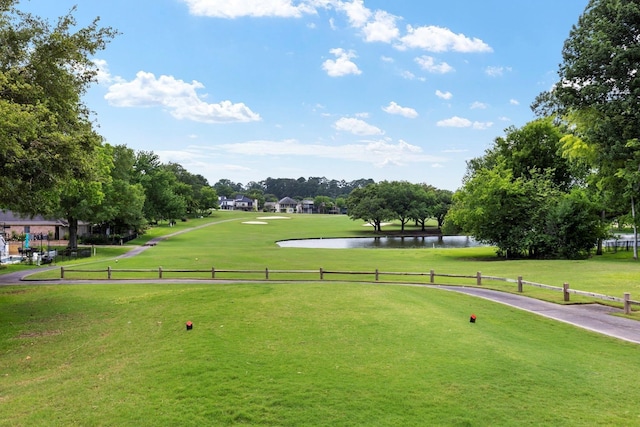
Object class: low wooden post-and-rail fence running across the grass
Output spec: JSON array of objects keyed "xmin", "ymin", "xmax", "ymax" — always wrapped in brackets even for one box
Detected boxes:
[{"xmin": 60, "ymin": 266, "xmax": 640, "ymax": 314}]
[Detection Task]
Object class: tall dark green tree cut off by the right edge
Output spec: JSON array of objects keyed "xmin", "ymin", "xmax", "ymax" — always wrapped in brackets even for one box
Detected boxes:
[{"xmin": 534, "ymin": 0, "xmax": 640, "ymax": 258}]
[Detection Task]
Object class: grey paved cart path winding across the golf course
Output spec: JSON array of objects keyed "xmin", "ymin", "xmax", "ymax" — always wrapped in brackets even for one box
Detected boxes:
[{"xmin": 0, "ymin": 220, "xmax": 640, "ymax": 344}]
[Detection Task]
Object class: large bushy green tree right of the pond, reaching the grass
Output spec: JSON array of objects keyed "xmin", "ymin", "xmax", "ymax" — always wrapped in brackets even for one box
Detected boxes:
[{"xmin": 447, "ymin": 120, "xmax": 604, "ymax": 258}]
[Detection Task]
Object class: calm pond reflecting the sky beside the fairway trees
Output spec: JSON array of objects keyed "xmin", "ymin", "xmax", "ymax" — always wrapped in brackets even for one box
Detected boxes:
[{"xmin": 276, "ymin": 236, "xmax": 484, "ymax": 249}]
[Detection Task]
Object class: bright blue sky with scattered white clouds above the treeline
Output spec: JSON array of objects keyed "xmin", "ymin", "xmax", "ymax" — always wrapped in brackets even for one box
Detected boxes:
[{"xmin": 18, "ymin": 0, "xmax": 588, "ymax": 190}]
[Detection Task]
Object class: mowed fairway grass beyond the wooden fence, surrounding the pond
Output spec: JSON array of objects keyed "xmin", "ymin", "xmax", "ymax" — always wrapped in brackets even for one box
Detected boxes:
[{"xmin": 34, "ymin": 212, "xmax": 640, "ymax": 308}]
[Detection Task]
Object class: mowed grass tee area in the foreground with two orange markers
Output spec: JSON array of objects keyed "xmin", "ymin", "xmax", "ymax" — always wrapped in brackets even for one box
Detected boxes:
[{"xmin": 0, "ymin": 283, "xmax": 640, "ymax": 426}]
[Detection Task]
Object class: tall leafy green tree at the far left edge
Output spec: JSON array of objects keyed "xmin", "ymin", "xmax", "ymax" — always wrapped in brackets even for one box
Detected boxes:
[{"xmin": 0, "ymin": 0, "xmax": 116, "ymax": 214}]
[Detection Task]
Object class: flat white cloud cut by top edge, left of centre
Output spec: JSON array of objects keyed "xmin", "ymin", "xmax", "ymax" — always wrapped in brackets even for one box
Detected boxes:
[{"xmin": 182, "ymin": 0, "xmax": 316, "ymax": 18}]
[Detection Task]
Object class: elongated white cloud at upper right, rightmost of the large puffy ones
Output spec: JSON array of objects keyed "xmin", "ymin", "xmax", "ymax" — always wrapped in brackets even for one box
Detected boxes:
[{"xmin": 396, "ymin": 25, "xmax": 493, "ymax": 53}]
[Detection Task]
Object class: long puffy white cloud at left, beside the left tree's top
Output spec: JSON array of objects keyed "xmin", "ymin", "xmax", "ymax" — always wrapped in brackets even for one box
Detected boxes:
[{"xmin": 105, "ymin": 71, "xmax": 261, "ymax": 123}]
